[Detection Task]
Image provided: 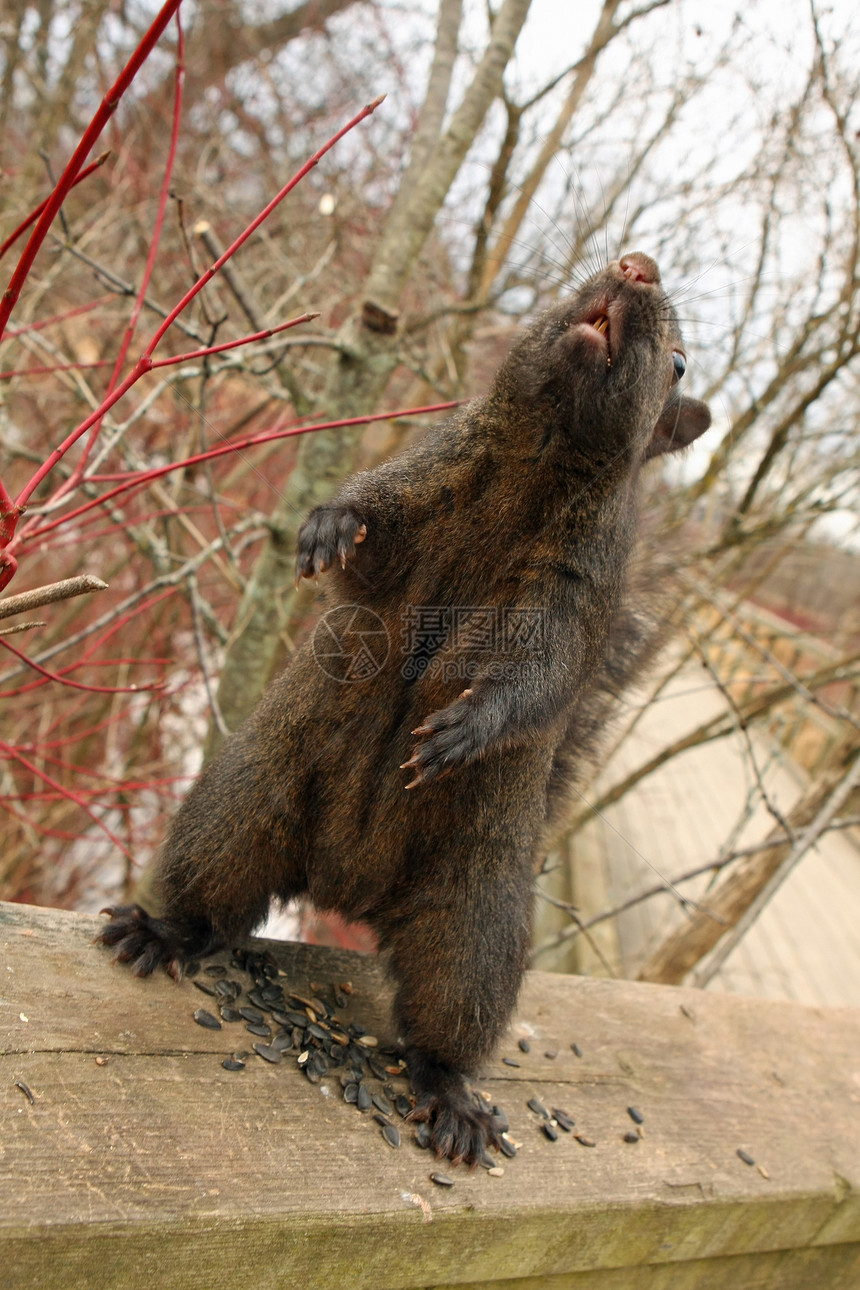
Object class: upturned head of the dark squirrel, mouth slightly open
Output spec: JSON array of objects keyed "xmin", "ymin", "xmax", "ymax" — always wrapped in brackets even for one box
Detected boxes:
[{"xmin": 490, "ymin": 253, "xmax": 710, "ymax": 464}]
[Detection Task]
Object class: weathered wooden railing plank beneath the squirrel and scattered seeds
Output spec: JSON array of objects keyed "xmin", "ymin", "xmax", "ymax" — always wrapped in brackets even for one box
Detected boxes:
[{"xmin": 0, "ymin": 906, "xmax": 860, "ymax": 1290}]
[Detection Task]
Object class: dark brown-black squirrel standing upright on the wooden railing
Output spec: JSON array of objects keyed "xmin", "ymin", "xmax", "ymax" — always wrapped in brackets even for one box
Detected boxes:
[{"xmin": 99, "ymin": 254, "xmax": 710, "ymax": 1164}]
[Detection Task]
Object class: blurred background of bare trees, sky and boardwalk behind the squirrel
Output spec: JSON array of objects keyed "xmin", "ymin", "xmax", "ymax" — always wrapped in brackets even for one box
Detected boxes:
[{"xmin": 0, "ymin": 0, "xmax": 860, "ymax": 1002}]
